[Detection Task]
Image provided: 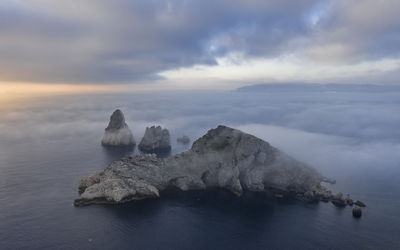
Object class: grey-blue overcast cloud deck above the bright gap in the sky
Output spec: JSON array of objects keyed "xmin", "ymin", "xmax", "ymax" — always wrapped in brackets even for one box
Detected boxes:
[{"xmin": 0, "ymin": 0, "xmax": 400, "ymax": 84}]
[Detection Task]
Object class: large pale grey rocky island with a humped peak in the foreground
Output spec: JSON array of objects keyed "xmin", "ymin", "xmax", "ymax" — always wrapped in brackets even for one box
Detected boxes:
[{"xmin": 74, "ymin": 126, "xmax": 346, "ymax": 206}]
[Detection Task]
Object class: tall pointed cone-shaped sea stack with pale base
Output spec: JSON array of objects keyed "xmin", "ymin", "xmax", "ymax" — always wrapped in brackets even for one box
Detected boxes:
[{"xmin": 101, "ymin": 109, "xmax": 135, "ymax": 146}]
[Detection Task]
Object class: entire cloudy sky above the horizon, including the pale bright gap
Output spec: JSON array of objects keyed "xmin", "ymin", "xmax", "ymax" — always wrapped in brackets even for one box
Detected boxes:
[{"xmin": 0, "ymin": 0, "xmax": 400, "ymax": 93}]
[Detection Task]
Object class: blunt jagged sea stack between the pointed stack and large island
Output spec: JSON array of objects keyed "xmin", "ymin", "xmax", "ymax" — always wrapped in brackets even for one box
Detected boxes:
[{"xmin": 139, "ymin": 126, "xmax": 171, "ymax": 153}]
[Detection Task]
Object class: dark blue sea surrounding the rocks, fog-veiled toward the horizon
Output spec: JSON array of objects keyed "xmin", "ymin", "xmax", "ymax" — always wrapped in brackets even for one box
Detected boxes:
[{"xmin": 0, "ymin": 91, "xmax": 400, "ymax": 249}]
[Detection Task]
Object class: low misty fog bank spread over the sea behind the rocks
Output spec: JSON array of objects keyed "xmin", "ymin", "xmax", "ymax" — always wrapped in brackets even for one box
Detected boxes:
[{"xmin": 0, "ymin": 89, "xmax": 400, "ymax": 178}]
